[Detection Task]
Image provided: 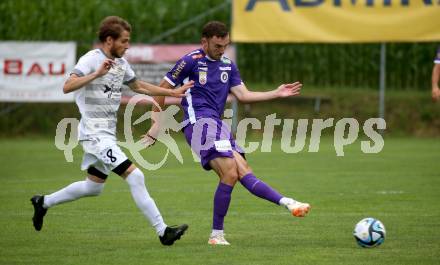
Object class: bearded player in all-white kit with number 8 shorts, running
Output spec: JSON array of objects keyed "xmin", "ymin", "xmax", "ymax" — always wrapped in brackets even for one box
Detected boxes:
[{"xmin": 31, "ymin": 16, "xmax": 192, "ymax": 245}]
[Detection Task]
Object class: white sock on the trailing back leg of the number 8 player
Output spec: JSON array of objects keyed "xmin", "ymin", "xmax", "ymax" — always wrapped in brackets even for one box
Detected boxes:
[{"xmin": 43, "ymin": 178, "xmax": 104, "ymax": 209}]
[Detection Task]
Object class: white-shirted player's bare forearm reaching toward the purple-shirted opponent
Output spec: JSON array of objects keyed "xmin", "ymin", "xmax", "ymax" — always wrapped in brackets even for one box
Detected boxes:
[{"xmin": 129, "ymin": 80, "xmax": 194, "ymax": 98}]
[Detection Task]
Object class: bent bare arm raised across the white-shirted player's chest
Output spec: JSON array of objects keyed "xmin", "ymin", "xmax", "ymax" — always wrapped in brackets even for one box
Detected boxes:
[{"xmin": 63, "ymin": 59, "xmax": 115, "ymax": 94}]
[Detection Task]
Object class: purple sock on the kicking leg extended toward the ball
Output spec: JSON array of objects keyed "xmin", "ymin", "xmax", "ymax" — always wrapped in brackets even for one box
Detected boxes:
[{"xmin": 240, "ymin": 173, "xmax": 283, "ymax": 204}]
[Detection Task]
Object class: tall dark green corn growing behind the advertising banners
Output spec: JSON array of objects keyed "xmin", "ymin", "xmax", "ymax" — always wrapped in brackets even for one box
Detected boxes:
[{"xmin": 0, "ymin": 0, "xmax": 437, "ymax": 90}]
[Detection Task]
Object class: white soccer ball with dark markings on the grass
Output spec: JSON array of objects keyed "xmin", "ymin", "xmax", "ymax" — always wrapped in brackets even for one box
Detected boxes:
[{"xmin": 353, "ymin": 217, "xmax": 386, "ymax": 248}]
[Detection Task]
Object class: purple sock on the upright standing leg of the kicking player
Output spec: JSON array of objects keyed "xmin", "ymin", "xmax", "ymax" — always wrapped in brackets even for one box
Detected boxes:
[{"xmin": 212, "ymin": 182, "xmax": 234, "ymax": 230}]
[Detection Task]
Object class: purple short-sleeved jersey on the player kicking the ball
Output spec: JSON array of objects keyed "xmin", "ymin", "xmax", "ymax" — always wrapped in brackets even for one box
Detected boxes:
[{"xmin": 164, "ymin": 49, "xmax": 241, "ymax": 124}]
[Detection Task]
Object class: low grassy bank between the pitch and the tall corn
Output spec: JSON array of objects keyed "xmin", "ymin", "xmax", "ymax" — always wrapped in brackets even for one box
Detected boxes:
[{"xmin": 0, "ymin": 89, "xmax": 440, "ymax": 137}]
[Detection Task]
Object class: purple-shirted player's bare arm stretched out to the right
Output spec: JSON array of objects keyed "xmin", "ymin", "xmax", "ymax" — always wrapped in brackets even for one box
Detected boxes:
[{"xmin": 231, "ymin": 82, "xmax": 302, "ymax": 103}]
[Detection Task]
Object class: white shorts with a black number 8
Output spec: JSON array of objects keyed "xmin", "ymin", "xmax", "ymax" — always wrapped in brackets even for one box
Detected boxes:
[{"xmin": 80, "ymin": 138, "xmax": 128, "ymax": 175}]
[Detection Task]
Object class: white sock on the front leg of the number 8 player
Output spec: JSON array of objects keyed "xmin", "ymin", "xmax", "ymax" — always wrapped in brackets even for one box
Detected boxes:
[{"xmin": 125, "ymin": 168, "xmax": 167, "ymax": 236}]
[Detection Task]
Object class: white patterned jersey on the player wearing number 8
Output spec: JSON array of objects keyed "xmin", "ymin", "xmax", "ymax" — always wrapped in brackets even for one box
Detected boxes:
[{"xmin": 72, "ymin": 49, "xmax": 136, "ymax": 140}]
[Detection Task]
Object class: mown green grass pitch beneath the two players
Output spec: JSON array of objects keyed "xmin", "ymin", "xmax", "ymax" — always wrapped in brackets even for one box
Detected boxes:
[{"xmin": 0, "ymin": 135, "xmax": 440, "ymax": 265}]
